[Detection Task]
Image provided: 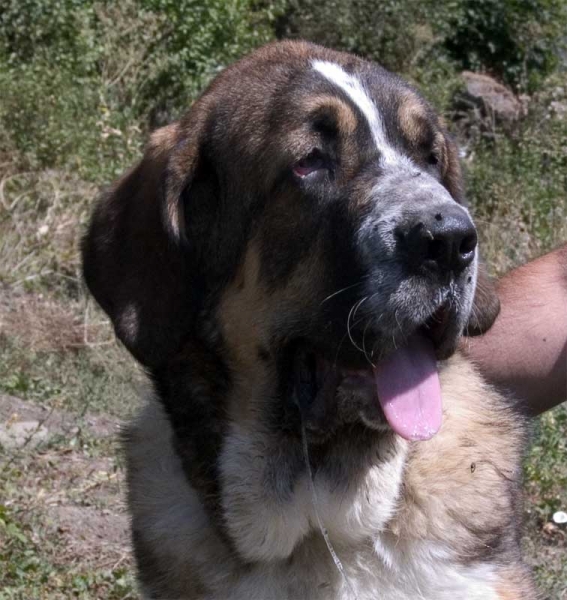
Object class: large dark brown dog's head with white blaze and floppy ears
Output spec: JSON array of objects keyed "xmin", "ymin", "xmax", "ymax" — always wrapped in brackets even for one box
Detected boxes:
[{"xmin": 84, "ymin": 42, "xmax": 498, "ymax": 564}]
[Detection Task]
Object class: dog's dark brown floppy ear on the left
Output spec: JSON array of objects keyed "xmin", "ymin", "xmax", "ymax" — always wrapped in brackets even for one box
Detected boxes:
[{"xmin": 82, "ymin": 107, "xmax": 216, "ymax": 367}]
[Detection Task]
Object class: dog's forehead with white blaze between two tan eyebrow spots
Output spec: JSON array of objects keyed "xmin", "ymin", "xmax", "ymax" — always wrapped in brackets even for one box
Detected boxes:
[{"xmin": 276, "ymin": 58, "xmax": 441, "ymax": 167}]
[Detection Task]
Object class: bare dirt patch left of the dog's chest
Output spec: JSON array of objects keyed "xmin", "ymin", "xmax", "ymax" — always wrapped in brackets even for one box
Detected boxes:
[{"xmin": 0, "ymin": 395, "xmax": 132, "ymax": 595}]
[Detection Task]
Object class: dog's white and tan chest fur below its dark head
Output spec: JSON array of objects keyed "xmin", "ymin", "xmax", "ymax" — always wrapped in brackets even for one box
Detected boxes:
[{"xmin": 127, "ymin": 354, "xmax": 524, "ymax": 600}]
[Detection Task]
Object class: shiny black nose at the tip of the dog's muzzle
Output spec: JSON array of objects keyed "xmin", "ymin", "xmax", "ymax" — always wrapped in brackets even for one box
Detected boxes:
[{"xmin": 396, "ymin": 204, "xmax": 477, "ymax": 274}]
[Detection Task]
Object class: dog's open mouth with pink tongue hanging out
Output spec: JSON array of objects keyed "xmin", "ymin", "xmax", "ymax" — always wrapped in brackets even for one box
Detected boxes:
[{"xmin": 293, "ymin": 306, "xmax": 457, "ymax": 440}]
